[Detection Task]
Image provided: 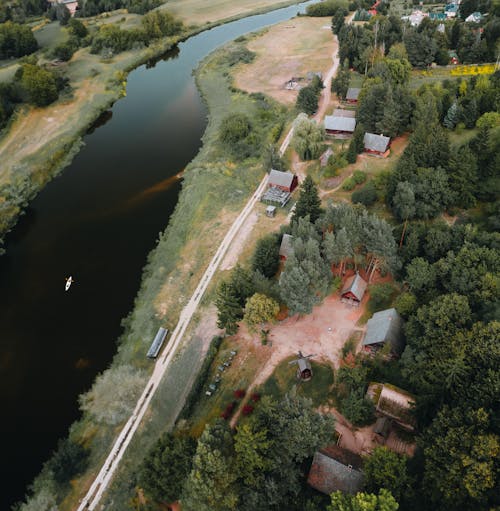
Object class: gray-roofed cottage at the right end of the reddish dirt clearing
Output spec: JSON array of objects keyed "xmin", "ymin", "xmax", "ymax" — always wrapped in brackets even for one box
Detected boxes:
[{"xmin": 363, "ymin": 308, "xmax": 404, "ymax": 354}]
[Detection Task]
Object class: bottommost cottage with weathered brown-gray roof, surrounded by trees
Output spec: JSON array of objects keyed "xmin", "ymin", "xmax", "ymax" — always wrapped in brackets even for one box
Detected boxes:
[{"xmin": 307, "ymin": 445, "xmax": 363, "ymax": 495}]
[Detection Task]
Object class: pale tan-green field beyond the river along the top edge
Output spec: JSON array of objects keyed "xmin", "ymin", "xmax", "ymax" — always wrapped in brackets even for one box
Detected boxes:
[{"xmin": 162, "ymin": 0, "xmax": 296, "ymax": 25}]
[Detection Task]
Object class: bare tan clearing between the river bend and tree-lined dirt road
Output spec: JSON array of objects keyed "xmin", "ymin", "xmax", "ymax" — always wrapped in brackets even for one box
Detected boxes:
[{"xmin": 235, "ymin": 16, "xmax": 337, "ymax": 104}]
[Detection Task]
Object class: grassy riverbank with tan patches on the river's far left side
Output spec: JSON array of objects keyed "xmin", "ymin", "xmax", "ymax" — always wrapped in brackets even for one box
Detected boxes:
[{"xmin": 0, "ymin": 0, "xmax": 308, "ymax": 255}]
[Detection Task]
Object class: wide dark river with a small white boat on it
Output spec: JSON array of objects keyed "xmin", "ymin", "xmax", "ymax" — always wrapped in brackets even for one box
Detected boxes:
[{"xmin": 0, "ymin": 2, "xmax": 312, "ymax": 510}]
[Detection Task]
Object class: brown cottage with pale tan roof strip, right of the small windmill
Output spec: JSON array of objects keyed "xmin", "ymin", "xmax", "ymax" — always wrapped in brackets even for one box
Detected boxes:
[{"xmin": 366, "ymin": 383, "xmax": 415, "ymax": 431}]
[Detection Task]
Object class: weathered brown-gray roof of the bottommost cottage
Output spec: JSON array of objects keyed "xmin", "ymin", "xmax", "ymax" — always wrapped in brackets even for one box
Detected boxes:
[{"xmin": 307, "ymin": 448, "xmax": 363, "ymax": 495}]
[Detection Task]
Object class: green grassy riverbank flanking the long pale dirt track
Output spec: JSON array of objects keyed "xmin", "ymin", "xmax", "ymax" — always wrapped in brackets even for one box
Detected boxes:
[{"xmin": 12, "ymin": 23, "xmax": 300, "ymax": 510}]
